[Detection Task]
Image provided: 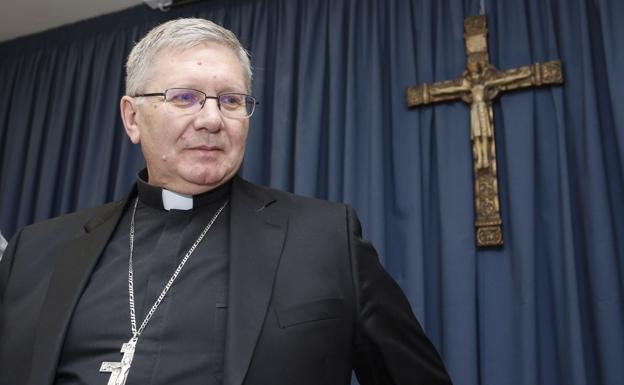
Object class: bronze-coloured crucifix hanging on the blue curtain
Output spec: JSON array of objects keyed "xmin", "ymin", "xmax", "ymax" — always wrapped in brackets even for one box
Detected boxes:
[{"xmin": 406, "ymin": 15, "xmax": 563, "ymax": 247}]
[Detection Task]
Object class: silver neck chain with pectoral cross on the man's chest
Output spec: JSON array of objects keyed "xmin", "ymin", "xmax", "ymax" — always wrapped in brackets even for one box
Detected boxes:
[{"xmin": 100, "ymin": 197, "xmax": 229, "ymax": 385}]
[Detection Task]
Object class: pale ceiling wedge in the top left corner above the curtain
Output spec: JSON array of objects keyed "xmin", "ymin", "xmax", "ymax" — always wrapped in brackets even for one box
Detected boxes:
[{"xmin": 0, "ymin": 0, "xmax": 142, "ymax": 42}]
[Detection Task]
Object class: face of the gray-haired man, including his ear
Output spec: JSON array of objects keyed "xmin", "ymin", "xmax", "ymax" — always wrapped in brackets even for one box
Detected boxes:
[{"xmin": 121, "ymin": 43, "xmax": 249, "ymax": 194}]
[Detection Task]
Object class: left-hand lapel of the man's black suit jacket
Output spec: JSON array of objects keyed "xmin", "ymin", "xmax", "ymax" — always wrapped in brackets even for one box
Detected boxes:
[{"xmin": 28, "ymin": 195, "xmax": 134, "ymax": 385}]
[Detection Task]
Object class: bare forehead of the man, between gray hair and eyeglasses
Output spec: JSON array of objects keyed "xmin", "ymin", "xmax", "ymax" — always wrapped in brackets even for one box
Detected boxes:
[{"xmin": 149, "ymin": 43, "xmax": 247, "ymax": 90}]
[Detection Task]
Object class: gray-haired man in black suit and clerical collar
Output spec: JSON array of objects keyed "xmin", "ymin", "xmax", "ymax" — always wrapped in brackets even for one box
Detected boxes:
[{"xmin": 0, "ymin": 19, "xmax": 450, "ymax": 385}]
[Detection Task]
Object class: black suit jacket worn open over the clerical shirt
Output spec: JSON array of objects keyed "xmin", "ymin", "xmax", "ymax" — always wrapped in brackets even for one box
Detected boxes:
[{"xmin": 0, "ymin": 177, "xmax": 450, "ymax": 385}]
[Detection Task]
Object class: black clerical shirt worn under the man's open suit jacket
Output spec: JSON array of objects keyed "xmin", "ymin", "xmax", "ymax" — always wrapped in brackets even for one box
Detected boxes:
[{"xmin": 55, "ymin": 171, "xmax": 230, "ymax": 385}]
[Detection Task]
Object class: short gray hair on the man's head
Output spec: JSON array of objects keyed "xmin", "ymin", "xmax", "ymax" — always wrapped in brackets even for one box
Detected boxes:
[{"xmin": 126, "ymin": 18, "xmax": 252, "ymax": 95}]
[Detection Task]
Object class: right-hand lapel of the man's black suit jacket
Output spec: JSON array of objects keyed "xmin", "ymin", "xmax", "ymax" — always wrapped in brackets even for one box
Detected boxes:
[{"xmin": 223, "ymin": 178, "xmax": 288, "ymax": 385}]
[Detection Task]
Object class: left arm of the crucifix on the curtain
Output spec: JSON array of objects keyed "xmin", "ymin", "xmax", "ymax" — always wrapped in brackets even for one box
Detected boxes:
[{"xmin": 405, "ymin": 78, "xmax": 470, "ymax": 107}]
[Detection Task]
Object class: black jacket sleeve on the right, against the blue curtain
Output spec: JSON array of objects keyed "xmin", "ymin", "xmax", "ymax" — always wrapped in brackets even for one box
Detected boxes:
[{"xmin": 347, "ymin": 207, "xmax": 451, "ymax": 385}]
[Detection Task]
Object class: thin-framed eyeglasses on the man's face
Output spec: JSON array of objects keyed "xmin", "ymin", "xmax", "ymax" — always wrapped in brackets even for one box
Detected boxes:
[{"xmin": 133, "ymin": 88, "xmax": 260, "ymax": 118}]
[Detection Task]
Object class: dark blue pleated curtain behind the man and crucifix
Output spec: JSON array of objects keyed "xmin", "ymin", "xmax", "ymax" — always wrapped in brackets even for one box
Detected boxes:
[{"xmin": 0, "ymin": 0, "xmax": 624, "ymax": 385}]
